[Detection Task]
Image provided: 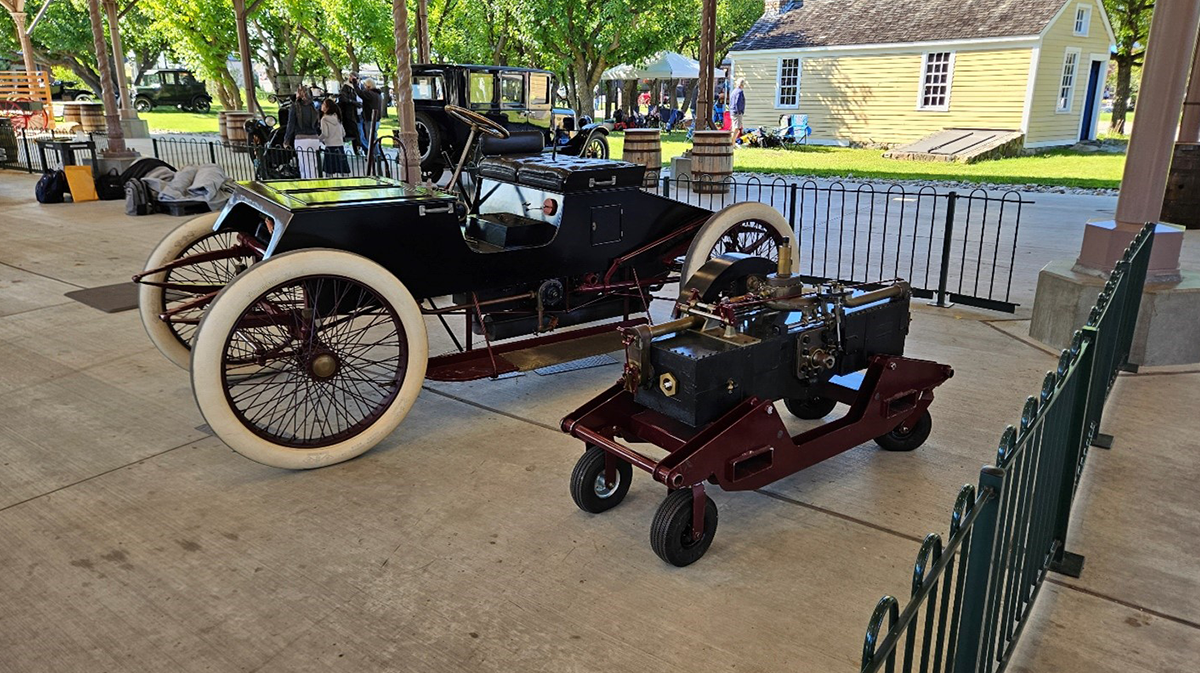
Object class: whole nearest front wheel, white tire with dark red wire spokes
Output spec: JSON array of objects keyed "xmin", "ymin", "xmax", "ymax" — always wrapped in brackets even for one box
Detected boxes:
[{"xmin": 192, "ymin": 248, "xmax": 428, "ymax": 469}]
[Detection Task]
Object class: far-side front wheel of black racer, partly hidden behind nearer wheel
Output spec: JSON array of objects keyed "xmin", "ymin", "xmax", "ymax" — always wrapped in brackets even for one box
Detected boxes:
[{"xmin": 138, "ymin": 212, "xmax": 258, "ymax": 369}]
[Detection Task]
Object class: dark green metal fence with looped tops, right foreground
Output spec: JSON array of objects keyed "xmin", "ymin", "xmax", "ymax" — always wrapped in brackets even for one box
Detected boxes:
[{"xmin": 862, "ymin": 224, "xmax": 1153, "ymax": 673}]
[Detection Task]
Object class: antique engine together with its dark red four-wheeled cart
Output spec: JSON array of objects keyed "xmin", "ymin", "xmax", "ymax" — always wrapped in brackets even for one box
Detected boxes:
[{"xmin": 562, "ymin": 246, "xmax": 954, "ymax": 566}]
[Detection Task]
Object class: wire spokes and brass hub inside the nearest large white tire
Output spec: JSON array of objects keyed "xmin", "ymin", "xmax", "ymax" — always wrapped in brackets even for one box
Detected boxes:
[{"xmin": 222, "ymin": 276, "xmax": 409, "ymax": 449}]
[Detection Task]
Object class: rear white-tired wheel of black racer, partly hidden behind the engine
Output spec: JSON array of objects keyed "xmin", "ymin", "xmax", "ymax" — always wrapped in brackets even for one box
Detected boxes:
[{"xmin": 682, "ymin": 202, "xmax": 799, "ymax": 282}]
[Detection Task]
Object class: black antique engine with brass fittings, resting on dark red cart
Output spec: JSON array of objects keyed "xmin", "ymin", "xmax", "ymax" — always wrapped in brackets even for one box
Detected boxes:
[{"xmin": 624, "ymin": 245, "xmax": 912, "ymax": 427}]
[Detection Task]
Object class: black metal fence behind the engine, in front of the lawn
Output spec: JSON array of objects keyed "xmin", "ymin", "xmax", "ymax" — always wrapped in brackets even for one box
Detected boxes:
[{"xmin": 659, "ymin": 178, "xmax": 1033, "ymax": 313}]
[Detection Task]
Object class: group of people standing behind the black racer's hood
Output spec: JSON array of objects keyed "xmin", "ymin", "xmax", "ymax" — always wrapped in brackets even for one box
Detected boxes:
[{"xmin": 283, "ymin": 74, "xmax": 384, "ymax": 180}]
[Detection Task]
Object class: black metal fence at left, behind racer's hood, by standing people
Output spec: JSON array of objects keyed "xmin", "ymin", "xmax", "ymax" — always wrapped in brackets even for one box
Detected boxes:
[{"xmin": 152, "ymin": 137, "xmax": 403, "ymax": 180}]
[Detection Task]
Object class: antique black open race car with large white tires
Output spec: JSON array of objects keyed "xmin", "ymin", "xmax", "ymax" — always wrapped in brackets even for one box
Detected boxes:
[{"xmin": 134, "ymin": 108, "xmax": 788, "ymax": 468}]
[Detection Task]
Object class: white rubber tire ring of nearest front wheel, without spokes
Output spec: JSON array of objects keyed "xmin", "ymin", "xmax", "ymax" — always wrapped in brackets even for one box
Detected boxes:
[{"xmin": 192, "ymin": 248, "xmax": 430, "ymax": 469}]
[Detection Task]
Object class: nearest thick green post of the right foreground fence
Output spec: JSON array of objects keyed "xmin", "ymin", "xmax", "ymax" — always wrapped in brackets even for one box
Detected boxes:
[{"xmin": 952, "ymin": 465, "xmax": 1006, "ymax": 673}]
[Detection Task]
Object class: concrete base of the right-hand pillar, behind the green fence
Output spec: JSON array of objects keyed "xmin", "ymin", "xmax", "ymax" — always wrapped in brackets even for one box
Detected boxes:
[{"xmin": 1030, "ymin": 260, "xmax": 1200, "ymax": 366}]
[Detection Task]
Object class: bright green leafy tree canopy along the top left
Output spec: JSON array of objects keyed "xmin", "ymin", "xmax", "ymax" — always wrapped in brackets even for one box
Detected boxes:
[{"xmin": 0, "ymin": 0, "xmax": 763, "ymax": 112}]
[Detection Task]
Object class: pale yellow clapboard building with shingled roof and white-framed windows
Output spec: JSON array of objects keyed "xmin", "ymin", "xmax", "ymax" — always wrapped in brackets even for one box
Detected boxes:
[{"xmin": 730, "ymin": 0, "xmax": 1114, "ymax": 148}]
